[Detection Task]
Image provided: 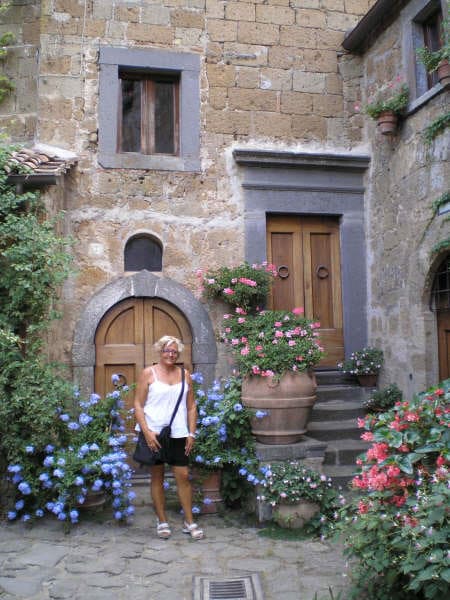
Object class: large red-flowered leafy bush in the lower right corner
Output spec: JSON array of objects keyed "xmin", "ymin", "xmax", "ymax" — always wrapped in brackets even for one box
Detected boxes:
[{"xmin": 340, "ymin": 380, "xmax": 450, "ymax": 600}]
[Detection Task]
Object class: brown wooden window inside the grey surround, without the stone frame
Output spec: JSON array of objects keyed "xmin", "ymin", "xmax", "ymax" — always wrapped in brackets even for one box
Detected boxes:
[{"xmin": 118, "ymin": 68, "xmax": 179, "ymax": 154}]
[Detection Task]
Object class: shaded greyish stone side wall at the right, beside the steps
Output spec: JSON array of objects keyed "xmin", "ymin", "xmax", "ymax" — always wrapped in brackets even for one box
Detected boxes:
[{"xmin": 363, "ymin": 10, "xmax": 450, "ymax": 395}]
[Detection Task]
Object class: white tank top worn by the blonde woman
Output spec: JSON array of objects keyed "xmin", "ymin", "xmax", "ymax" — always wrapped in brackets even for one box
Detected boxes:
[{"xmin": 144, "ymin": 367, "xmax": 189, "ymax": 438}]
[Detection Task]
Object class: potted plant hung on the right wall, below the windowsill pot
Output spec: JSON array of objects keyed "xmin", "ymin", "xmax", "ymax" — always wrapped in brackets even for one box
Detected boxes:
[{"xmin": 355, "ymin": 77, "xmax": 409, "ymax": 135}]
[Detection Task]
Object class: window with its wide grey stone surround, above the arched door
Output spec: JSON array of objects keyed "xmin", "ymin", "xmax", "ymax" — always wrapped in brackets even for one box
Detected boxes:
[{"xmin": 99, "ymin": 47, "xmax": 200, "ymax": 171}]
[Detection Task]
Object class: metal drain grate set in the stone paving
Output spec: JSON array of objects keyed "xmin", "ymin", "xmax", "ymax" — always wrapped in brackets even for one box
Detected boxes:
[{"xmin": 194, "ymin": 575, "xmax": 264, "ymax": 600}]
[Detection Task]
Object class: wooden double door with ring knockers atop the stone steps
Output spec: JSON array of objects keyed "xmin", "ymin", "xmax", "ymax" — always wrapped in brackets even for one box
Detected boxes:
[{"xmin": 267, "ymin": 215, "xmax": 344, "ymax": 368}]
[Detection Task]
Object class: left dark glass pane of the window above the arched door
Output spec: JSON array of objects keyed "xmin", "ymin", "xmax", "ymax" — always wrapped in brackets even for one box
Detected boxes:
[{"xmin": 120, "ymin": 79, "xmax": 141, "ymax": 152}]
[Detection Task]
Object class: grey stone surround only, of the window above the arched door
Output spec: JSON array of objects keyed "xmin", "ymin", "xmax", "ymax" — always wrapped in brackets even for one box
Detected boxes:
[{"xmin": 99, "ymin": 46, "xmax": 200, "ymax": 171}]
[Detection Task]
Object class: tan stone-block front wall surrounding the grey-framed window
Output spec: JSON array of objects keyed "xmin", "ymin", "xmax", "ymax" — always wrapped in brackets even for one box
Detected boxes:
[{"xmin": 0, "ymin": 0, "xmax": 384, "ymax": 376}]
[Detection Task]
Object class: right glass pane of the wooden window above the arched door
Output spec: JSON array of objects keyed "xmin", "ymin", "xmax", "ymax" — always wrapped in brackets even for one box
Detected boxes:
[{"xmin": 154, "ymin": 81, "xmax": 175, "ymax": 154}]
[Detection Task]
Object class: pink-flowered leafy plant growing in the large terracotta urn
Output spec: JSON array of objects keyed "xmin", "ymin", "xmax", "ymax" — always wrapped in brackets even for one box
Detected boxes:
[{"xmin": 222, "ymin": 307, "xmax": 323, "ymax": 379}]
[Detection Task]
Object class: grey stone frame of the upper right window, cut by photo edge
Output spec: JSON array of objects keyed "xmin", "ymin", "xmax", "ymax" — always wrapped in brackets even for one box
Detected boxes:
[{"xmin": 401, "ymin": 0, "xmax": 447, "ymax": 112}]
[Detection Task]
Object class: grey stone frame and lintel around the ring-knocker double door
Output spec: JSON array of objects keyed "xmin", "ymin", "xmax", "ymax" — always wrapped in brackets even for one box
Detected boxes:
[{"xmin": 233, "ymin": 148, "xmax": 370, "ymax": 356}]
